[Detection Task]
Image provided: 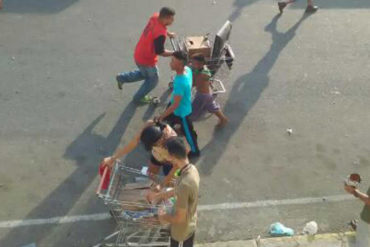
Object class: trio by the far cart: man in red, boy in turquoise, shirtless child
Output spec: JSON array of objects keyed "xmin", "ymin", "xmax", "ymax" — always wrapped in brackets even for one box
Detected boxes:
[{"xmin": 116, "ymin": 7, "xmax": 228, "ymax": 156}]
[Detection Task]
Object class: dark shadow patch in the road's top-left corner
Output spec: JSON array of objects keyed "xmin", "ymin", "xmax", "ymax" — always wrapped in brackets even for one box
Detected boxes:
[{"xmin": 2, "ymin": 0, "xmax": 78, "ymax": 14}]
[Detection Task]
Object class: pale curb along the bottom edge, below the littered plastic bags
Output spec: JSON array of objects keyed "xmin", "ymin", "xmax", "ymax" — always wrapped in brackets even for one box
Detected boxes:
[{"xmin": 195, "ymin": 232, "xmax": 355, "ymax": 247}]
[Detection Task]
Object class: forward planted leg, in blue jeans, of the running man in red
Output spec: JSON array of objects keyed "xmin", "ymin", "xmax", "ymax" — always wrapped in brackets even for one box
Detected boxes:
[{"xmin": 134, "ymin": 66, "xmax": 159, "ymax": 103}]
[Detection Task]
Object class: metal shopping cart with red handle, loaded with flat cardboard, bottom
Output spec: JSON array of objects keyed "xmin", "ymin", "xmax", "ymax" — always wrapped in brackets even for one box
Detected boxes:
[{"xmin": 94, "ymin": 161, "xmax": 174, "ymax": 247}]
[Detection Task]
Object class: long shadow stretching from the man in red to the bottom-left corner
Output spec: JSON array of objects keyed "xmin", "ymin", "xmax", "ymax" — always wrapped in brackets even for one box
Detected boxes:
[{"xmin": 0, "ymin": 103, "xmax": 136, "ymax": 246}]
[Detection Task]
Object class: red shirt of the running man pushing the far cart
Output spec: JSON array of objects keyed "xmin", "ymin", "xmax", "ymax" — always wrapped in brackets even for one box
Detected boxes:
[{"xmin": 134, "ymin": 13, "xmax": 167, "ymax": 67}]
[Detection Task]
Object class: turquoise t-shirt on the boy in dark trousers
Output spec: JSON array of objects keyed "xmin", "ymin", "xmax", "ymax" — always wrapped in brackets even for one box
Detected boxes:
[{"xmin": 171, "ymin": 66, "xmax": 193, "ymax": 117}]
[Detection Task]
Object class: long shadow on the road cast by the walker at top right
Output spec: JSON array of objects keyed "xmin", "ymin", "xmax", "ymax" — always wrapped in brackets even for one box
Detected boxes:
[{"xmin": 199, "ymin": 14, "xmax": 309, "ymax": 175}]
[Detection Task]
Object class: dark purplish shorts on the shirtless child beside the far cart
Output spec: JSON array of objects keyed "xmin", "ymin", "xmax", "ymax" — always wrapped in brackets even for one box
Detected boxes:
[{"xmin": 190, "ymin": 92, "xmax": 220, "ymax": 121}]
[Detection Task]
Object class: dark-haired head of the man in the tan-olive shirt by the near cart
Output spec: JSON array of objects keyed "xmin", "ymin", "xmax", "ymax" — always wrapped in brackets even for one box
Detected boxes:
[{"xmin": 164, "ymin": 137, "xmax": 187, "ymax": 166}]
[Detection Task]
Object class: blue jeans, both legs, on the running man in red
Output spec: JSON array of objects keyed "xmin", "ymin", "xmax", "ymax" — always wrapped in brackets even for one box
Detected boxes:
[{"xmin": 116, "ymin": 64, "xmax": 159, "ymax": 103}]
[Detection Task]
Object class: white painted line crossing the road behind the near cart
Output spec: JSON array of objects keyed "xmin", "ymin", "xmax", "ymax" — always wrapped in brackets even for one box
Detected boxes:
[{"xmin": 0, "ymin": 195, "xmax": 354, "ymax": 228}]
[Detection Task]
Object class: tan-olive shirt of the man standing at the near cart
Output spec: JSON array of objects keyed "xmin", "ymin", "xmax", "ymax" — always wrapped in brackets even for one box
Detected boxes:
[{"xmin": 171, "ymin": 165, "xmax": 199, "ymax": 242}]
